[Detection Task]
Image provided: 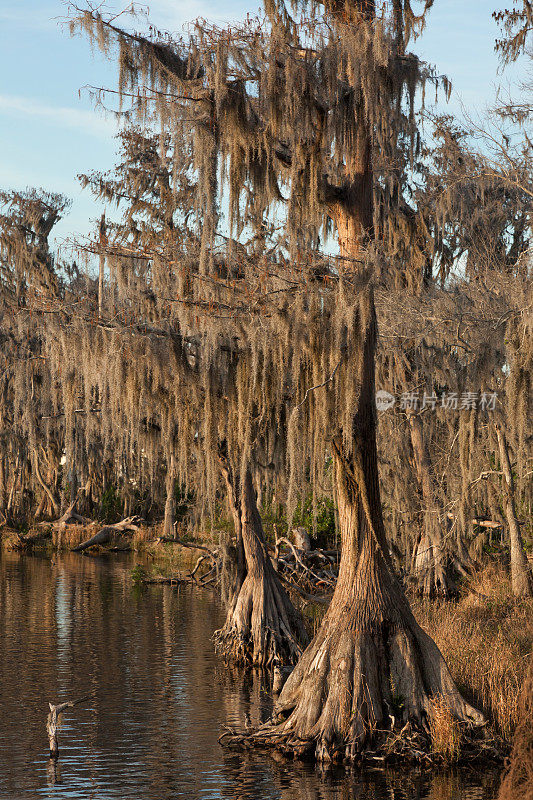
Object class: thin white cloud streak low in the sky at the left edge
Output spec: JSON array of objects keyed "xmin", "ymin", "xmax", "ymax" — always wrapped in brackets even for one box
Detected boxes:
[{"xmin": 0, "ymin": 94, "xmax": 117, "ymax": 138}]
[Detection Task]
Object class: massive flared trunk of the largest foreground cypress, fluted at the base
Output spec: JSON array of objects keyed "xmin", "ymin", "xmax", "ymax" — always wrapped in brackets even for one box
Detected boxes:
[{"xmin": 233, "ymin": 293, "xmax": 484, "ymax": 761}]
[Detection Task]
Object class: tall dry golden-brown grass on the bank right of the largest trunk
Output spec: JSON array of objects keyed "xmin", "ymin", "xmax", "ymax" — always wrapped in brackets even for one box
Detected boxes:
[{"xmin": 413, "ymin": 566, "xmax": 533, "ymax": 740}]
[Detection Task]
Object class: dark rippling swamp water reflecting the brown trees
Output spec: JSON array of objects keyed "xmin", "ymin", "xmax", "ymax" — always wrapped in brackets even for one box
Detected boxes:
[{"xmin": 0, "ymin": 553, "xmax": 499, "ymax": 800}]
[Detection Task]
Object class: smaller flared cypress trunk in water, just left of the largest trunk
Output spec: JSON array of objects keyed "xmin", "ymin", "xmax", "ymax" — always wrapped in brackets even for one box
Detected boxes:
[{"xmin": 215, "ymin": 468, "xmax": 307, "ymax": 666}]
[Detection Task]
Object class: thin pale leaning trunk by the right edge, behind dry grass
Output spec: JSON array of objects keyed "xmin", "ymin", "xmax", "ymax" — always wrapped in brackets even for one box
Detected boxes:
[{"xmin": 496, "ymin": 425, "xmax": 533, "ymax": 597}]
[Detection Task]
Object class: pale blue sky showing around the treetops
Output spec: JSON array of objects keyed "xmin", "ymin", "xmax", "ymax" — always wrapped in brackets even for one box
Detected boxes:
[{"xmin": 0, "ymin": 0, "xmax": 521, "ymax": 244}]
